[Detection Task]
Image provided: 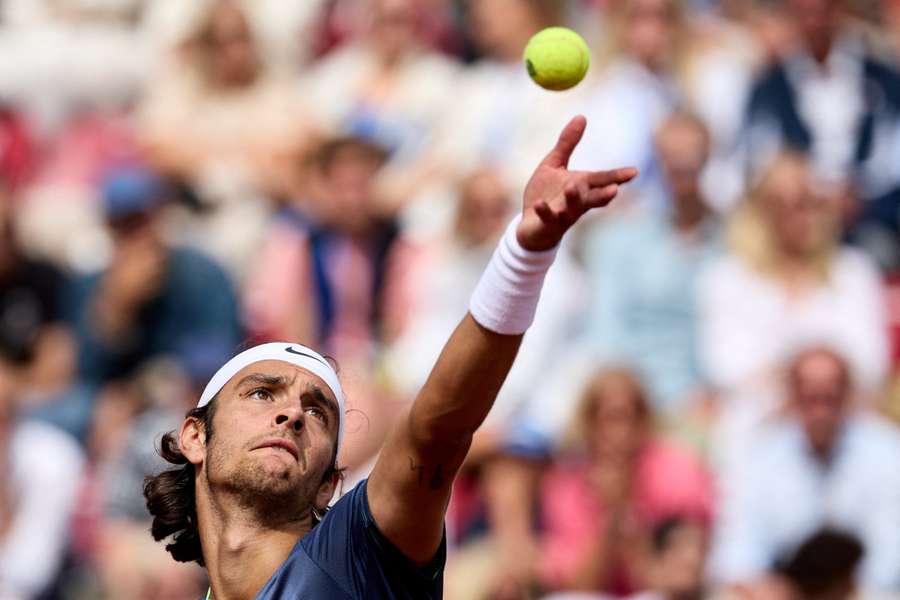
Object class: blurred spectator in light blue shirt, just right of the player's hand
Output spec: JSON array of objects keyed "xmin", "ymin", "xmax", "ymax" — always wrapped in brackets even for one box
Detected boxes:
[{"xmin": 585, "ymin": 113, "xmax": 719, "ymax": 419}]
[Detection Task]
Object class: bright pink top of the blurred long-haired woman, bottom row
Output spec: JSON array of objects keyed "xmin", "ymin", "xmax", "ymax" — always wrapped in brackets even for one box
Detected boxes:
[{"xmin": 540, "ymin": 440, "xmax": 713, "ymax": 593}]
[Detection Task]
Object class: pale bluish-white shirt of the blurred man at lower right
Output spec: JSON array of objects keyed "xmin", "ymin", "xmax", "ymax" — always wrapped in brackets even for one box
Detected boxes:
[{"xmin": 711, "ymin": 416, "xmax": 900, "ymax": 592}]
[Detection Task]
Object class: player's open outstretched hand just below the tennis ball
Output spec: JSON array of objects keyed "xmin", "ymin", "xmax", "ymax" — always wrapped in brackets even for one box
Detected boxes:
[{"xmin": 516, "ymin": 116, "xmax": 637, "ymax": 251}]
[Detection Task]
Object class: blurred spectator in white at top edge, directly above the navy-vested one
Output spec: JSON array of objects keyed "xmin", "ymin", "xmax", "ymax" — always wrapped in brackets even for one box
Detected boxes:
[{"xmin": 303, "ymin": 0, "xmax": 457, "ymax": 225}]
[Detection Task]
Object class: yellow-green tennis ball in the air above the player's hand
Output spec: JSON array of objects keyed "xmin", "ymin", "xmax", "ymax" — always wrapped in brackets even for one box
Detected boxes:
[{"xmin": 525, "ymin": 27, "xmax": 591, "ymax": 91}]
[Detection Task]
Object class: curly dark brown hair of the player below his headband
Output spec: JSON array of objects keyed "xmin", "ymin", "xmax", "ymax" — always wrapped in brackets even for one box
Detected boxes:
[{"xmin": 144, "ymin": 396, "xmax": 343, "ymax": 566}]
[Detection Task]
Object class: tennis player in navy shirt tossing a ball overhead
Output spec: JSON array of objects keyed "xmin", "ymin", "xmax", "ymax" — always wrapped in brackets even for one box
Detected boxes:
[{"xmin": 144, "ymin": 117, "xmax": 637, "ymax": 600}]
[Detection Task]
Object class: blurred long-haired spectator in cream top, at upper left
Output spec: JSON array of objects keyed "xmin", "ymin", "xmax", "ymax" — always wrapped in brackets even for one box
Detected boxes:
[{"xmin": 141, "ymin": 0, "xmax": 309, "ymax": 189}]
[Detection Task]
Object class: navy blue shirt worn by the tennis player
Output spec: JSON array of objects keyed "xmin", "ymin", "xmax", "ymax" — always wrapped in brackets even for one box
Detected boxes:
[{"xmin": 256, "ymin": 480, "xmax": 447, "ymax": 600}]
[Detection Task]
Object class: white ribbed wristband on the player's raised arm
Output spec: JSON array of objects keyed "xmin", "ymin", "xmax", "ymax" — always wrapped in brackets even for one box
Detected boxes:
[{"xmin": 469, "ymin": 215, "xmax": 559, "ymax": 335}]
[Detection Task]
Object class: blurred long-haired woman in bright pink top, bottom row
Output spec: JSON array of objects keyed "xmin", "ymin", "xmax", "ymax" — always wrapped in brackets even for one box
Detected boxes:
[{"xmin": 539, "ymin": 370, "xmax": 712, "ymax": 594}]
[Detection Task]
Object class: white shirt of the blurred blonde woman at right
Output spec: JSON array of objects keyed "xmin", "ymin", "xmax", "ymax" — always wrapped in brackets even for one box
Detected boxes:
[{"xmin": 698, "ymin": 249, "xmax": 888, "ymax": 392}]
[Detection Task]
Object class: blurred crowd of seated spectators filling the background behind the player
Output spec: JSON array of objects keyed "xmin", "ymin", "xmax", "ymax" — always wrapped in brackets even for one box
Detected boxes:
[{"xmin": 0, "ymin": 0, "xmax": 900, "ymax": 600}]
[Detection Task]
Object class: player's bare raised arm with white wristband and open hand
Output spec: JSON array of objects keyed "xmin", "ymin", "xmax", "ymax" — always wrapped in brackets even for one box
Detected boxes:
[{"xmin": 368, "ymin": 117, "xmax": 637, "ymax": 563}]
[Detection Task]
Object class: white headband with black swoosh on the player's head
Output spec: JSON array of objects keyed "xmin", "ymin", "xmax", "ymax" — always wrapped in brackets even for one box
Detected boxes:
[{"xmin": 197, "ymin": 342, "xmax": 344, "ymax": 448}]
